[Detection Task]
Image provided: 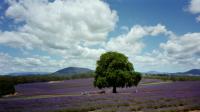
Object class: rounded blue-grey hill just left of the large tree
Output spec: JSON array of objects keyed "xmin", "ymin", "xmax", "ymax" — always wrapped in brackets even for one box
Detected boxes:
[{"xmin": 53, "ymin": 67, "xmax": 93, "ymax": 74}]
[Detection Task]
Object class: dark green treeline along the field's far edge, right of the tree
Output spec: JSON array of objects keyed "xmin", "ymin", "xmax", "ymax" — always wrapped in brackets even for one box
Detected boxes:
[{"xmin": 143, "ymin": 74, "xmax": 200, "ymax": 81}]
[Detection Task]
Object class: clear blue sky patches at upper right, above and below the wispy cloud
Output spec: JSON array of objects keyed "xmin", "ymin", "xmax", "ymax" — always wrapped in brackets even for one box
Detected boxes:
[{"xmin": 106, "ymin": 0, "xmax": 200, "ymax": 55}]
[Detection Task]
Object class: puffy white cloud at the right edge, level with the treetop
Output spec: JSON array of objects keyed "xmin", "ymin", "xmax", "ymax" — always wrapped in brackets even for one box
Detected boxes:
[{"xmin": 160, "ymin": 33, "xmax": 200, "ymax": 65}]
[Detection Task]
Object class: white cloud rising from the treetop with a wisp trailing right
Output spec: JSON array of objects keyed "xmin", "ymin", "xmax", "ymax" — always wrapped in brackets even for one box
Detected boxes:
[{"xmin": 106, "ymin": 24, "xmax": 171, "ymax": 56}]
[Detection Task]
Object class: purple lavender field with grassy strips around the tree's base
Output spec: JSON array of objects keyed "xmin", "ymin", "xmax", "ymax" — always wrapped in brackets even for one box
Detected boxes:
[{"xmin": 0, "ymin": 78, "xmax": 200, "ymax": 112}]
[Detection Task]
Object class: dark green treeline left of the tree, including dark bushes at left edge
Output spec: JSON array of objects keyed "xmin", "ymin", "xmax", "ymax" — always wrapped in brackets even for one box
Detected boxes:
[{"xmin": 0, "ymin": 72, "xmax": 94, "ymax": 97}]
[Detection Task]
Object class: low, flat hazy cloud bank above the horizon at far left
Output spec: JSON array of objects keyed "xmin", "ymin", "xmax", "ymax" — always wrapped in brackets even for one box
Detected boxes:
[{"xmin": 0, "ymin": 53, "xmax": 64, "ymax": 74}]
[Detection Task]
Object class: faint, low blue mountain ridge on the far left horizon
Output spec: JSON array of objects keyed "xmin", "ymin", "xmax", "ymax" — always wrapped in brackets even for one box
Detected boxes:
[{"xmin": 7, "ymin": 72, "xmax": 49, "ymax": 76}]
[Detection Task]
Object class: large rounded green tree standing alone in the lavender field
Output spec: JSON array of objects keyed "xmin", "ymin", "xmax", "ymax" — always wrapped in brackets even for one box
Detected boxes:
[{"xmin": 94, "ymin": 51, "xmax": 141, "ymax": 93}]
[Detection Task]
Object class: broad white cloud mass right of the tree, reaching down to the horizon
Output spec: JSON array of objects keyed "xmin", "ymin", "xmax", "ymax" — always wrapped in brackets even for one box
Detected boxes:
[{"xmin": 132, "ymin": 33, "xmax": 200, "ymax": 72}]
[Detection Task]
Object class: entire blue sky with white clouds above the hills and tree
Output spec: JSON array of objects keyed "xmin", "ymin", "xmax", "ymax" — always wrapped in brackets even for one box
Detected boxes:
[{"xmin": 0, "ymin": 0, "xmax": 200, "ymax": 74}]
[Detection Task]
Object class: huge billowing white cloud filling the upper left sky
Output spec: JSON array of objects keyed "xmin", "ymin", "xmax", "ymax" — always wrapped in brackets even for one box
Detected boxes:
[{"xmin": 0, "ymin": 0, "xmax": 118, "ymax": 52}]
